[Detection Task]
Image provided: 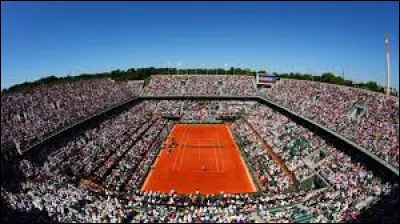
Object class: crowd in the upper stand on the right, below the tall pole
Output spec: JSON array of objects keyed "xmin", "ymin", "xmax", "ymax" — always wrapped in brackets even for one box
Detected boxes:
[{"xmin": 259, "ymin": 79, "xmax": 399, "ymax": 169}]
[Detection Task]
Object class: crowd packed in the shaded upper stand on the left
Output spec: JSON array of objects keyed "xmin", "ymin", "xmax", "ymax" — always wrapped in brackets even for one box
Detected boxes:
[{"xmin": 1, "ymin": 79, "xmax": 140, "ymax": 156}]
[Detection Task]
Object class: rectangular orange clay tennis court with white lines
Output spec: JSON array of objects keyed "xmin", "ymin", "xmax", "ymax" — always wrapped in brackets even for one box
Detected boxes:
[{"xmin": 142, "ymin": 124, "xmax": 256, "ymax": 194}]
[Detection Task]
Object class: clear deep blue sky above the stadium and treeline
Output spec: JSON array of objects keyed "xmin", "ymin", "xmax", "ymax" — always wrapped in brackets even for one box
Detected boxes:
[{"xmin": 1, "ymin": 1, "xmax": 399, "ymax": 89}]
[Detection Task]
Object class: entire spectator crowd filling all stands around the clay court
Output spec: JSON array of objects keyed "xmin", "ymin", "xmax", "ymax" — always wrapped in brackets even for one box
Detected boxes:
[{"xmin": 1, "ymin": 75, "xmax": 398, "ymax": 223}]
